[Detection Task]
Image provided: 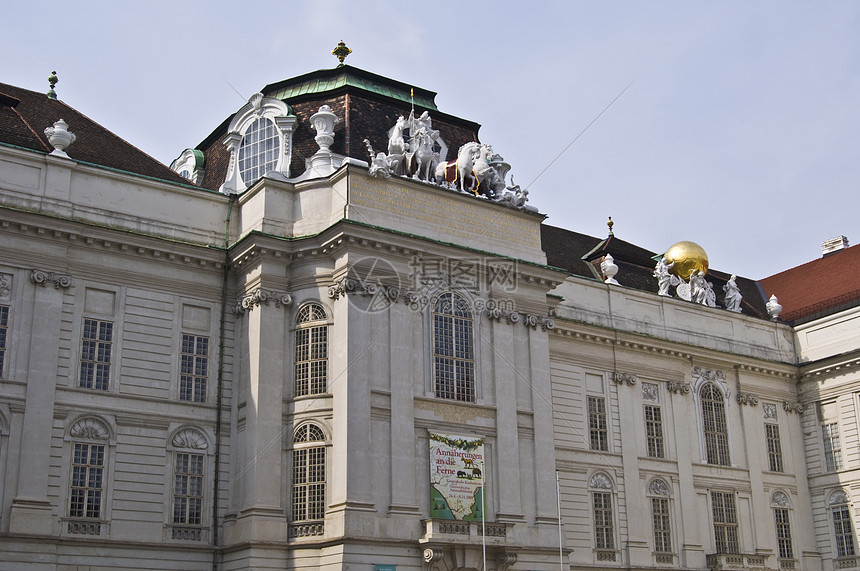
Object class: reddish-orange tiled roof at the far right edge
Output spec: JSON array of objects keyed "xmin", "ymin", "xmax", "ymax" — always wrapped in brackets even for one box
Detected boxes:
[{"xmin": 761, "ymin": 246, "xmax": 860, "ymax": 321}]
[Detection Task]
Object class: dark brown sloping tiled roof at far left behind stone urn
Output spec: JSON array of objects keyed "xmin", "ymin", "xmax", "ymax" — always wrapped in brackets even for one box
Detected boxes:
[{"xmin": 0, "ymin": 83, "xmax": 189, "ymax": 184}]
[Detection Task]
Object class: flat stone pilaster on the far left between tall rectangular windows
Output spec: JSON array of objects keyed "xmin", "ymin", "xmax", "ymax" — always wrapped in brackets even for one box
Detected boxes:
[{"xmin": 9, "ymin": 270, "xmax": 72, "ymax": 535}]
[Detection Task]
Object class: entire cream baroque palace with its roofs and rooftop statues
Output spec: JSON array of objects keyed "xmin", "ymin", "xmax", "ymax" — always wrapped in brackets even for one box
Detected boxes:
[{"xmin": 0, "ymin": 54, "xmax": 860, "ymax": 571}]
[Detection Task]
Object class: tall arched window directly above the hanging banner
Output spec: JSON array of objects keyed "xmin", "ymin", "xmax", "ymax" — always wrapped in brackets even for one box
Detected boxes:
[{"xmin": 433, "ymin": 292, "xmax": 475, "ymax": 402}]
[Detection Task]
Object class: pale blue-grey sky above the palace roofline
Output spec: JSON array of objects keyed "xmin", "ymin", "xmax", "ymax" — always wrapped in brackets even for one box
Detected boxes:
[{"xmin": 0, "ymin": 0, "xmax": 860, "ymax": 284}]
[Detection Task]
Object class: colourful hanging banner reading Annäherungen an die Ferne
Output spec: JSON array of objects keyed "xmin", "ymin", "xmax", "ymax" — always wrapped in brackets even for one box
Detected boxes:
[{"xmin": 430, "ymin": 432, "xmax": 484, "ymax": 521}]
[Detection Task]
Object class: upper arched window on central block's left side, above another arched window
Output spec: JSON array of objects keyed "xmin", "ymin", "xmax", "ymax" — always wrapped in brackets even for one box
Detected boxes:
[{"xmin": 295, "ymin": 303, "xmax": 328, "ymax": 397}]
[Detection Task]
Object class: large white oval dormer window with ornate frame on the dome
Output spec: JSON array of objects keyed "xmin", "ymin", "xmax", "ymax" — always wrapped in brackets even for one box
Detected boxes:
[{"xmin": 220, "ymin": 93, "xmax": 296, "ymax": 194}]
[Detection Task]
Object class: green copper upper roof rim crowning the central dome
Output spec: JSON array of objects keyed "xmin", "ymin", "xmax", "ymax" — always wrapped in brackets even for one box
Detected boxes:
[{"xmin": 264, "ymin": 65, "xmax": 438, "ymax": 111}]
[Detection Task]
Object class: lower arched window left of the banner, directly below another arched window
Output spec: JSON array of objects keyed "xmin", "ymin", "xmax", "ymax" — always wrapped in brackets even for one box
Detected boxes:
[{"xmin": 290, "ymin": 423, "xmax": 326, "ymax": 536}]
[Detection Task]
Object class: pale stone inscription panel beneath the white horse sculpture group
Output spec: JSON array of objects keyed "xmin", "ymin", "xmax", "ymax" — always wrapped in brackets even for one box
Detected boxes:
[{"xmin": 348, "ymin": 178, "xmax": 546, "ymax": 264}]
